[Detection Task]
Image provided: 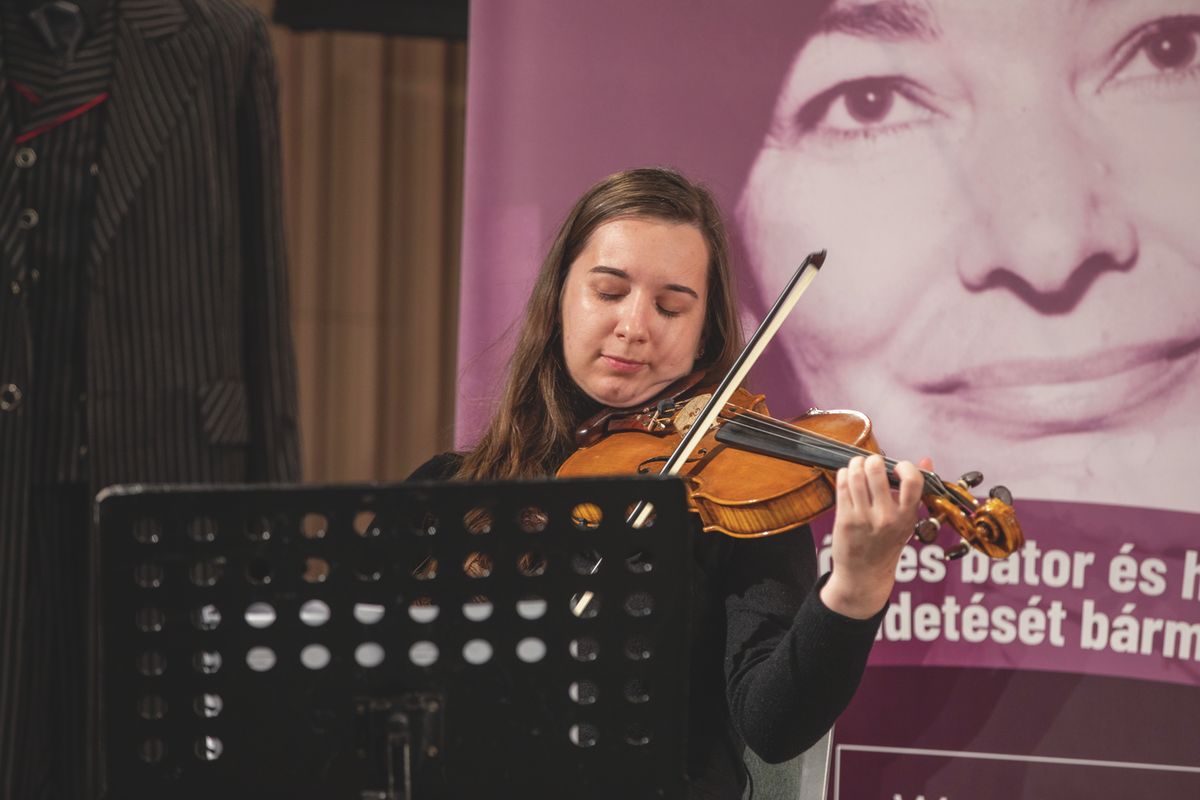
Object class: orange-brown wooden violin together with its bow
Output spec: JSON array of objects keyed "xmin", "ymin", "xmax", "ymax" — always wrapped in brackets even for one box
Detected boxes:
[{"xmin": 557, "ymin": 251, "xmax": 1025, "ymax": 560}]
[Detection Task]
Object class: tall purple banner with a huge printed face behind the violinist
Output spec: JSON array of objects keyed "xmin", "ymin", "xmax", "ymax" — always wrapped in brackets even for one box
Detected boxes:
[{"xmin": 457, "ymin": 0, "xmax": 1200, "ymax": 799}]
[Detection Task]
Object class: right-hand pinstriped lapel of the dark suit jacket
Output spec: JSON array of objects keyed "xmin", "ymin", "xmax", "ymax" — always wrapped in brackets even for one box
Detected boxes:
[{"xmin": 86, "ymin": 0, "xmax": 206, "ymax": 275}]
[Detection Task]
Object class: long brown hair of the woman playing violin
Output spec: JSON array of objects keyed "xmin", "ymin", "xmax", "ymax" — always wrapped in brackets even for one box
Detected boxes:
[{"xmin": 457, "ymin": 168, "xmax": 743, "ymax": 480}]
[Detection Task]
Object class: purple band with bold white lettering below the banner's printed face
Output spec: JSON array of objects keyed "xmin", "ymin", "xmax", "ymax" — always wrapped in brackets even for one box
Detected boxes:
[{"xmin": 818, "ymin": 501, "xmax": 1200, "ymax": 686}]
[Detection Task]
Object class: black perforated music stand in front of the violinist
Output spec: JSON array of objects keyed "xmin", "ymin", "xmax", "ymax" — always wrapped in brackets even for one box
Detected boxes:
[{"xmin": 97, "ymin": 479, "xmax": 692, "ymax": 800}]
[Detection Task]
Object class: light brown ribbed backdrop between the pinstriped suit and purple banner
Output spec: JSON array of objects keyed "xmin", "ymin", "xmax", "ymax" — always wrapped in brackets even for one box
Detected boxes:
[{"xmin": 250, "ymin": 0, "xmax": 467, "ymax": 481}]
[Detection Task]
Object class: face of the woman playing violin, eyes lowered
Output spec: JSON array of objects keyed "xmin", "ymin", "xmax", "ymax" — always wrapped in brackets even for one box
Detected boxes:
[{"xmin": 563, "ymin": 218, "xmax": 708, "ymax": 408}]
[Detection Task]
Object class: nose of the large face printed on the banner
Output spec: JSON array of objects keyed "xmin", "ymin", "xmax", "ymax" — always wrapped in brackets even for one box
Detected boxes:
[{"xmin": 958, "ymin": 88, "xmax": 1138, "ymax": 314}]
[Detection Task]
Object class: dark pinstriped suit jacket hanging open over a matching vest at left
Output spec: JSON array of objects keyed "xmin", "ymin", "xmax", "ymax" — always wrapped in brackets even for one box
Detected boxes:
[{"xmin": 0, "ymin": 0, "xmax": 299, "ymax": 799}]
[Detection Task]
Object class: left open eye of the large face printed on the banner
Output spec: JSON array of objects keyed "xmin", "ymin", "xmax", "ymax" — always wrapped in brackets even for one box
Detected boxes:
[{"xmin": 796, "ymin": 76, "xmax": 941, "ymax": 140}]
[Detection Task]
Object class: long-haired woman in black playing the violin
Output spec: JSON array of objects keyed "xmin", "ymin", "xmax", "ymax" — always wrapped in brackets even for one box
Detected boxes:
[{"xmin": 413, "ymin": 169, "xmax": 923, "ymax": 799}]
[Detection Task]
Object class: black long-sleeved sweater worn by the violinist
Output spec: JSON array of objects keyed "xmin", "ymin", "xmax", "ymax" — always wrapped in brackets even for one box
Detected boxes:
[{"xmin": 409, "ymin": 453, "xmax": 883, "ymax": 800}]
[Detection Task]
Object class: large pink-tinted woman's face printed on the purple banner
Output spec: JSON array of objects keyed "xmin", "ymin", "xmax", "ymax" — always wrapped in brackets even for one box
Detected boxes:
[{"xmin": 737, "ymin": 0, "xmax": 1200, "ymax": 511}]
